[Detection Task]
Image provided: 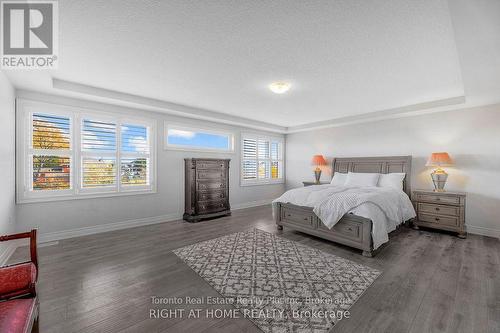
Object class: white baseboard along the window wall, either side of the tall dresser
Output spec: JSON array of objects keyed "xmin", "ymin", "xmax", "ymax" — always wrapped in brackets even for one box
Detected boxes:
[{"xmin": 38, "ymin": 199, "xmax": 272, "ymax": 244}]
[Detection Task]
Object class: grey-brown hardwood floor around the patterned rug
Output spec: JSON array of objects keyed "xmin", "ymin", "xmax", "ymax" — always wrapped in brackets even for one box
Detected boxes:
[{"xmin": 11, "ymin": 206, "xmax": 500, "ymax": 333}]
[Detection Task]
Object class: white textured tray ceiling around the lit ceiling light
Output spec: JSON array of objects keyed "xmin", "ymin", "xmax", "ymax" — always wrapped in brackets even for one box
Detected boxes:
[{"xmin": 3, "ymin": 0, "xmax": 500, "ymax": 127}]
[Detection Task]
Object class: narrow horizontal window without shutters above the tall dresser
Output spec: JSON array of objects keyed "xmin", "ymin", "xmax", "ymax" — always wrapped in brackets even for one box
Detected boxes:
[{"xmin": 165, "ymin": 123, "xmax": 234, "ymax": 152}]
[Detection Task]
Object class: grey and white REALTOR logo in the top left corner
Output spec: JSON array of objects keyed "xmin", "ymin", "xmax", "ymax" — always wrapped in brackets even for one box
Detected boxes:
[{"xmin": 1, "ymin": 1, "xmax": 58, "ymax": 69}]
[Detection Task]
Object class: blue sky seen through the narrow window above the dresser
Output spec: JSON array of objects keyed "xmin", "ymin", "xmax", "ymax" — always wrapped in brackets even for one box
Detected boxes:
[{"xmin": 168, "ymin": 129, "xmax": 231, "ymax": 150}]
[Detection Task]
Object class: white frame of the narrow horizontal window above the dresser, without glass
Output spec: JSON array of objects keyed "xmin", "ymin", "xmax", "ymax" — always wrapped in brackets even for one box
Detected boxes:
[{"xmin": 163, "ymin": 121, "xmax": 235, "ymax": 154}]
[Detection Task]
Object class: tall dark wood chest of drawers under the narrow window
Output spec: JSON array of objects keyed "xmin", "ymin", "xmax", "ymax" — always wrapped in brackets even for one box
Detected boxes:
[{"xmin": 184, "ymin": 158, "xmax": 231, "ymax": 222}]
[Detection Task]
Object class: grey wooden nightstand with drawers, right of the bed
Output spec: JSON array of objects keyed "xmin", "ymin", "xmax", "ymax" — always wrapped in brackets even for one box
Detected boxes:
[{"xmin": 412, "ymin": 190, "xmax": 467, "ymax": 238}]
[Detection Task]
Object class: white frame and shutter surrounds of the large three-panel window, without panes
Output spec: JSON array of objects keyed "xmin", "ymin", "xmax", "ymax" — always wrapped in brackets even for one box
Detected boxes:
[{"xmin": 16, "ymin": 98, "xmax": 157, "ymax": 203}]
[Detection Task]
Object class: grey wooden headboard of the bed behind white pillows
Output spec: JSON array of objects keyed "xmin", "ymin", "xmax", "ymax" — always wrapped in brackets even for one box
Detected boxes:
[{"xmin": 332, "ymin": 156, "xmax": 411, "ymax": 198}]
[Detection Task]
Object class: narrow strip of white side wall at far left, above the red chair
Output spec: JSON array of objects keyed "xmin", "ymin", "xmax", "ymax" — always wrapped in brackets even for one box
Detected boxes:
[{"xmin": 0, "ymin": 72, "xmax": 16, "ymax": 264}]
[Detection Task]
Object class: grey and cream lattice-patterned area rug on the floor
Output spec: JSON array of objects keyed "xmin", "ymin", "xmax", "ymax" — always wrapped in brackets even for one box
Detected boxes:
[{"xmin": 174, "ymin": 229, "xmax": 380, "ymax": 333}]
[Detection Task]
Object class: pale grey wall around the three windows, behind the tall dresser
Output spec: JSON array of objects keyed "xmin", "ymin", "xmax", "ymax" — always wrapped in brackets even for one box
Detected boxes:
[{"xmin": 12, "ymin": 91, "xmax": 285, "ymax": 241}]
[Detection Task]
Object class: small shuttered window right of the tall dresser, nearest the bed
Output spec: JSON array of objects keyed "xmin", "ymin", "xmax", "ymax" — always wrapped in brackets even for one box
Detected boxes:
[{"xmin": 241, "ymin": 134, "xmax": 284, "ymax": 185}]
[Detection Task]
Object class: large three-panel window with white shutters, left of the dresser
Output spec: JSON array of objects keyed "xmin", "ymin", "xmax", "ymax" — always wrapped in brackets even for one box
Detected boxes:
[{"xmin": 17, "ymin": 100, "xmax": 155, "ymax": 202}]
